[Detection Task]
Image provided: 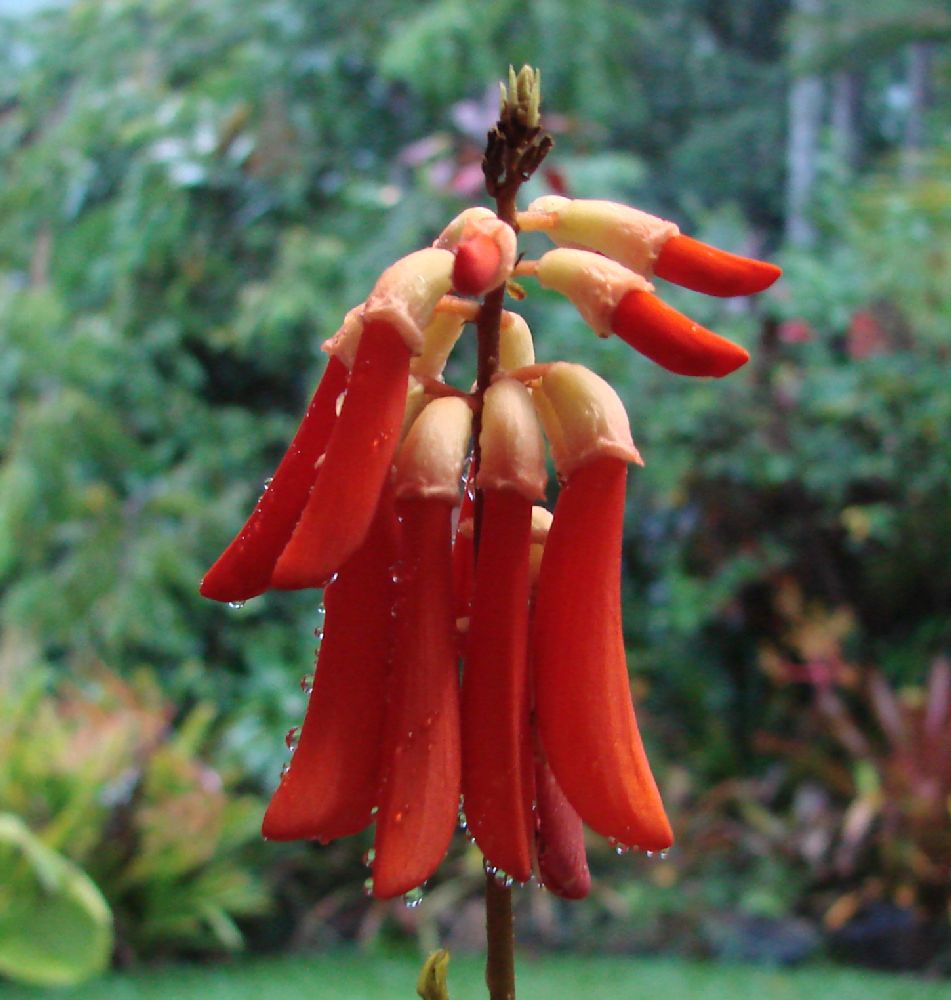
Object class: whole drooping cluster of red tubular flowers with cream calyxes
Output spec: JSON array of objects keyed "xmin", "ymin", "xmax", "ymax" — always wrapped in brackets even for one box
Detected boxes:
[{"xmin": 201, "ymin": 197, "xmax": 779, "ymax": 898}]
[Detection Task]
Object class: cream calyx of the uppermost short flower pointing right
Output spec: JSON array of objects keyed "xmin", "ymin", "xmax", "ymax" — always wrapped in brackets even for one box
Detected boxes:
[{"xmin": 519, "ymin": 195, "xmax": 680, "ymax": 277}]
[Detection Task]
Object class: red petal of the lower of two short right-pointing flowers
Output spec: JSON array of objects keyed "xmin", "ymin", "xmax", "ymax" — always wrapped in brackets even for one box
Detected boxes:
[{"xmin": 611, "ymin": 289, "xmax": 750, "ymax": 378}]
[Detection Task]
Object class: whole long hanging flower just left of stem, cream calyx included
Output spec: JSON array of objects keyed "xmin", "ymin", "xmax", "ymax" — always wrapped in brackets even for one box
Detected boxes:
[{"xmin": 373, "ymin": 397, "xmax": 472, "ymax": 899}]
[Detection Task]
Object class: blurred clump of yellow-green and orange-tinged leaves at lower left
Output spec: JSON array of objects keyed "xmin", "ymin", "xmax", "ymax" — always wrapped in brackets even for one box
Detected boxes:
[{"xmin": 0, "ymin": 668, "xmax": 268, "ymax": 960}]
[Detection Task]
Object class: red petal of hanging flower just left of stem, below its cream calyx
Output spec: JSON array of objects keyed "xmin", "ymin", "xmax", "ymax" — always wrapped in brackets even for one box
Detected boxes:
[{"xmin": 373, "ymin": 500, "xmax": 460, "ymax": 899}]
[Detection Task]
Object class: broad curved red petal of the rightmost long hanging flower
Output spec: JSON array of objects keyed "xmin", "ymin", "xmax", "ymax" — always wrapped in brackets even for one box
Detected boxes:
[{"xmin": 533, "ymin": 458, "xmax": 672, "ymax": 851}]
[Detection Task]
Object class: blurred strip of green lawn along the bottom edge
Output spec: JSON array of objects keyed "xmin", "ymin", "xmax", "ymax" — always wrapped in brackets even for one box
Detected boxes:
[{"xmin": 0, "ymin": 952, "xmax": 949, "ymax": 1000}]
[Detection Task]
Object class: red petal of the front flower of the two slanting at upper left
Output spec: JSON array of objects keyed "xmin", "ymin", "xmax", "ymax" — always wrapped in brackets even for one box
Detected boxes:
[{"xmin": 271, "ymin": 321, "xmax": 409, "ymax": 590}]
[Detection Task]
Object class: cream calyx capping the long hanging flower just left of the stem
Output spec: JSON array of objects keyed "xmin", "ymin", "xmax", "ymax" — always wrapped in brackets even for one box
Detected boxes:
[{"xmin": 393, "ymin": 396, "xmax": 472, "ymax": 504}]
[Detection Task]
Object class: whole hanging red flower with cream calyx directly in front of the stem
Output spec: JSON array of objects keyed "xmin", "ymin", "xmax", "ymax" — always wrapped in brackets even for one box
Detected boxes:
[{"xmin": 462, "ymin": 379, "xmax": 547, "ymax": 882}]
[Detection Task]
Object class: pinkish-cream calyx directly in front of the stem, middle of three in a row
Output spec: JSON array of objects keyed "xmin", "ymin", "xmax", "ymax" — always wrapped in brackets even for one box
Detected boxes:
[{"xmin": 476, "ymin": 378, "xmax": 548, "ymax": 500}]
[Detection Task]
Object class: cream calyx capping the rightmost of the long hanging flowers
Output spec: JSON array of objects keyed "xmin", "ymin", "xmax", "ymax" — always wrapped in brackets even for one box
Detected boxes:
[{"xmin": 533, "ymin": 361, "xmax": 643, "ymax": 477}]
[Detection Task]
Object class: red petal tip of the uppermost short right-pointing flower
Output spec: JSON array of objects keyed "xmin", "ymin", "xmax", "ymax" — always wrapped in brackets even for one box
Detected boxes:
[{"xmin": 654, "ymin": 235, "xmax": 783, "ymax": 298}]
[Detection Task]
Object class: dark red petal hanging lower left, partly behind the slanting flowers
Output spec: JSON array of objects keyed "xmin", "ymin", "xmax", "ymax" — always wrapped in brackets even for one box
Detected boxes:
[{"xmin": 263, "ymin": 491, "xmax": 397, "ymax": 842}]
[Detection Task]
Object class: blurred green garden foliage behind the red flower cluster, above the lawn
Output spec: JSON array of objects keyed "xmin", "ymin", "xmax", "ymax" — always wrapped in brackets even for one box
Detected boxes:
[{"xmin": 0, "ymin": 0, "xmax": 951, "ymax": 995}]
